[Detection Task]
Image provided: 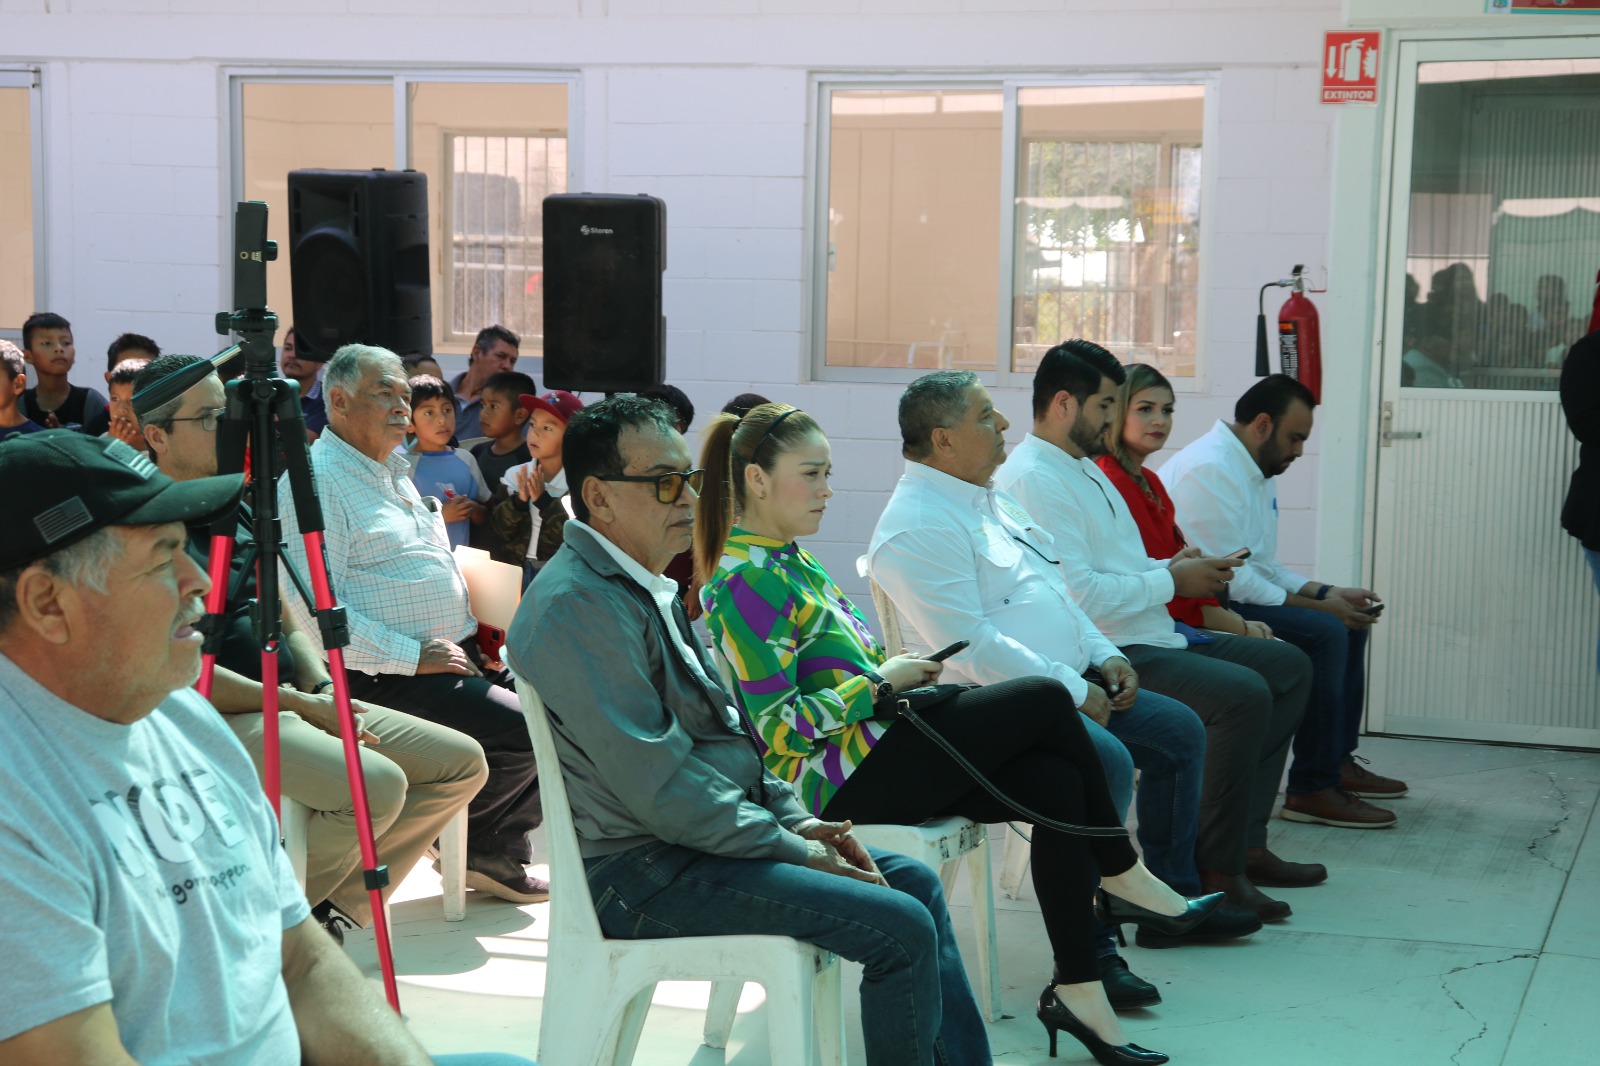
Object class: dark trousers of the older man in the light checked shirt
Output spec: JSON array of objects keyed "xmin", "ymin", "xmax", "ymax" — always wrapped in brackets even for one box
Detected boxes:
[{"xmin": 350, "ymin": 640, "xmax": 544, "ymax": 863}]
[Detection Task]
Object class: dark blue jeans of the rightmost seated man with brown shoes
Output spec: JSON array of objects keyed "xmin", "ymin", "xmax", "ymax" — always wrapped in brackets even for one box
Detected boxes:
[{"xmin": 1232, "ymin": 602, "xmax": 1366, "ymax": 795}]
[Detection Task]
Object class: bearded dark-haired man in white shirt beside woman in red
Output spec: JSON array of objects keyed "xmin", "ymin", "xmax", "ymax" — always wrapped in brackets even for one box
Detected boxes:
[{"xmin": 995, "ymin": 339, "xmax": 1328, "ymax": 922}]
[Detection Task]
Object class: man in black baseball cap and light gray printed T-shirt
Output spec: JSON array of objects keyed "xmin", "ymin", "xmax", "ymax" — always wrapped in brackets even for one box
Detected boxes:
[{"xmin": 0, "ymin": 431, "xmax": 451, "ymax": 1064}]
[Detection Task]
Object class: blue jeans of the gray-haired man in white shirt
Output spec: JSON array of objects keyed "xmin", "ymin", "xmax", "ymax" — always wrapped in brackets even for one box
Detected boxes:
[{"xmin": 1083, "ymin": 688, "xmax": 1205, "ymax": 896}]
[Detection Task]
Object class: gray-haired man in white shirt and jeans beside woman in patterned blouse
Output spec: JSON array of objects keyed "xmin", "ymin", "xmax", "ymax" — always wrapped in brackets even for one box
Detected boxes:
[{"xmin": 867, "ymin": 371, "xmax": 1261, "ymax": 1005}]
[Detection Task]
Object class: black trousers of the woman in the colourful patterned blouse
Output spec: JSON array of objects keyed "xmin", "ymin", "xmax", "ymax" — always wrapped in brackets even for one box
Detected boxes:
[{"xmin": 822, "ymin": 677, "xmax": 1138, "ymax": 983}]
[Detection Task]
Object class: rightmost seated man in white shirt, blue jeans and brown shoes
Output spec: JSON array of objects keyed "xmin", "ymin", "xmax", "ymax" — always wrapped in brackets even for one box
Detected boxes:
[{"xmin": 1162, "ymin": 375, "xmax": 1406, "ymax": 829}]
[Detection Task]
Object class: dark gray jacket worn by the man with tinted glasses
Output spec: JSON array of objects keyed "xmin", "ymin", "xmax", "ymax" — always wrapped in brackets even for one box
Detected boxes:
[{"xmin": 506, "ymin": 522, "xmax": 810, "ymax": 866}]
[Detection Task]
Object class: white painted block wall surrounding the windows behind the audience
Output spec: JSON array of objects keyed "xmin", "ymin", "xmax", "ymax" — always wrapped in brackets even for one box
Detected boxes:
[{"xmin": 0, "ymin": 0, "xmax": 1344, "ymax": 605}]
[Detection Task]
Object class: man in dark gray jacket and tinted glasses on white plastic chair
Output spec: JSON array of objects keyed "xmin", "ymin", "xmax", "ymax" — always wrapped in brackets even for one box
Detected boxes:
[{"xmin": 506, "ymin": 395, "xmax": 992, "ymax": 1066}]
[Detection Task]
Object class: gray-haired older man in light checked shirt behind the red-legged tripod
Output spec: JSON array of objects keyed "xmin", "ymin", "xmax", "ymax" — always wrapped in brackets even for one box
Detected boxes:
[{"xmin": 278, "ymin": 344, "xmax": 550, "ymax": 903}]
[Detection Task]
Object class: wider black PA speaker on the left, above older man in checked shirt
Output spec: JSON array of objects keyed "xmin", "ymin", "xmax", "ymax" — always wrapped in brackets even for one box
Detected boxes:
[{"xmin": 290, "ymin": 170, "xmax": 434, "ymax": 362}]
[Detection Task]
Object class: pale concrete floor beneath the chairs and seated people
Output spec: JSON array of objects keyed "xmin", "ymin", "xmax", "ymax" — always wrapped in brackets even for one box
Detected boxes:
[{"xmin": 349, "ymin": 738, "xmax": 1600, "ymax": 1066}]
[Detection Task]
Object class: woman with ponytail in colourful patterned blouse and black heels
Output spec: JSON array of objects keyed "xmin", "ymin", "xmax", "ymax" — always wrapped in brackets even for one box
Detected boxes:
[{"xmin": 694, "ymin": 403, "xmax": 1216, "ymax": 1063}]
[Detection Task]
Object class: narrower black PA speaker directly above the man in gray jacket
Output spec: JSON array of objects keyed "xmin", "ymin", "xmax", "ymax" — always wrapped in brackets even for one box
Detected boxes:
[{"xmin": 544, "ymin": 192, "xmax": 667, "ymax": 392}]
